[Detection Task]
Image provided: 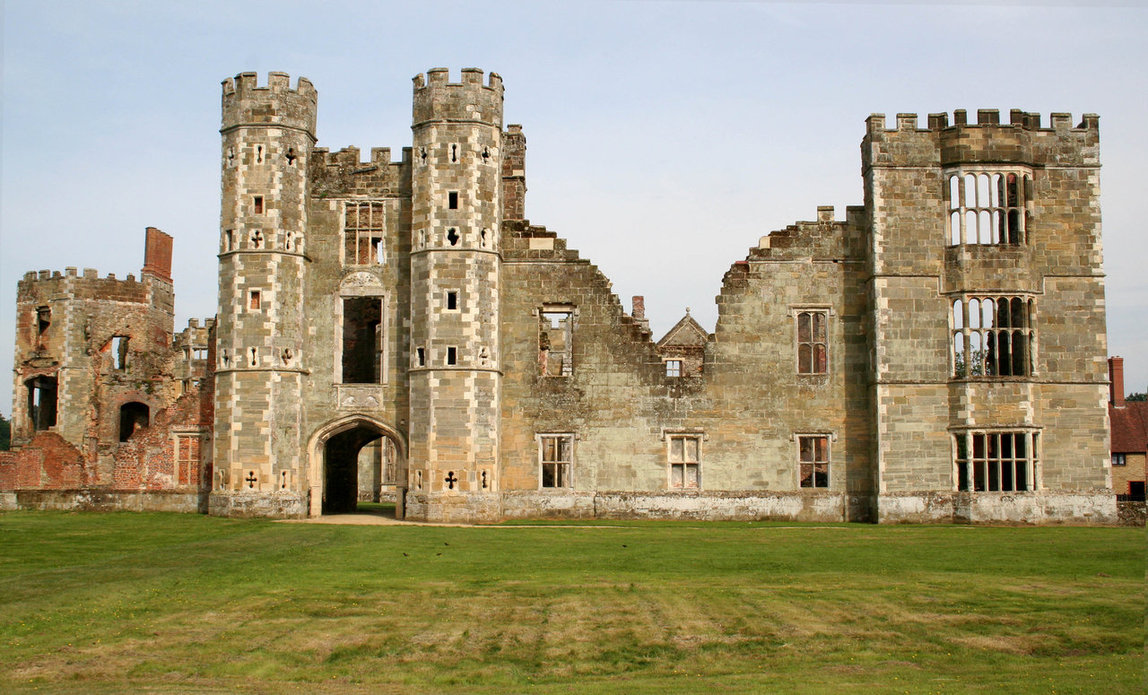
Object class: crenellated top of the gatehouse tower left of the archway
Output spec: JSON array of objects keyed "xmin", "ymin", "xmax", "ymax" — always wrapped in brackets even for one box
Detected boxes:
[{"xmin": 223, "ymin": 72, "xmax": 319, "ymax": 137}]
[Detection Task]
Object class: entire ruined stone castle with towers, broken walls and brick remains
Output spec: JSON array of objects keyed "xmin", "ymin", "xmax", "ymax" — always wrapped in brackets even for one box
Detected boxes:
[{"xmin": 0, "ymin": 69, "xmax": 1116, "ymax": 523}]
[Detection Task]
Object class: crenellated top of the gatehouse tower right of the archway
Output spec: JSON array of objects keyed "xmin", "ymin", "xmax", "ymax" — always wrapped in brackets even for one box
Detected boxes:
[{"xmin": 413, "ymin": 68, "xmax": 503, "ymax": 130}]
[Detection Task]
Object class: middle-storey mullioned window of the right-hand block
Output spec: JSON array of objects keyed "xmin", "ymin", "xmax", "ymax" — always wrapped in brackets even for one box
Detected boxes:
[{"xmin": 952, "ymin": 296, "xmax": 1035, "ymax": 378}]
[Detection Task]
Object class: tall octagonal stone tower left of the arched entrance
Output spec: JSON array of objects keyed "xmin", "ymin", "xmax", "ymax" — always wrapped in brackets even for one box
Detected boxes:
[{"xmin": 210, "ymin": 72, "xmax": 317, "ymax": 516}]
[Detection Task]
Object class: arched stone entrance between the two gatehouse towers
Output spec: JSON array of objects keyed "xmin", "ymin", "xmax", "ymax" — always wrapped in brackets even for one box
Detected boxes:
[{"xmin": 309, "ymin": 416, "xmax": 406, "ymax": 518}]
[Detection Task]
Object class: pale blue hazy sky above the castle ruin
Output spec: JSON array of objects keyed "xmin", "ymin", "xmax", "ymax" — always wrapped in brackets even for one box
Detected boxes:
[{"xmin": 0, "ymin": 0, "xmax": 1148, "ymax": 415}]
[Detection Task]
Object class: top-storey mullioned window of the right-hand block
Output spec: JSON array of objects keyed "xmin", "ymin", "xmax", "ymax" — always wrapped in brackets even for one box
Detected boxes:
[{"xmin": 945, "ymin": 171, "xmax": 1032, "ymax": 246}]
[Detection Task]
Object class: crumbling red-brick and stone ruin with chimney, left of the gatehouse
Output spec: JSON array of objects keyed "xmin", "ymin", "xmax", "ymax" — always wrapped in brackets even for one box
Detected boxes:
[{"xmin": 0, "ymin": 227, "xmax": 214, "ymax": 509}]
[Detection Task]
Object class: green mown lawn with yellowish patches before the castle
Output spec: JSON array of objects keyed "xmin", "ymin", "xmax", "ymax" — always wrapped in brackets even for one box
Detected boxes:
[{"xmin": 0, "ymin": 512, "xmax": 1145, "ymax": 695}]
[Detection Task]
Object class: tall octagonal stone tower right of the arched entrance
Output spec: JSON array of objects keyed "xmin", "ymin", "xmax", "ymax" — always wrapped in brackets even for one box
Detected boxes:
[{"xmin": 406, "ymin": 68, "xmax": 503, "ymax": 520}]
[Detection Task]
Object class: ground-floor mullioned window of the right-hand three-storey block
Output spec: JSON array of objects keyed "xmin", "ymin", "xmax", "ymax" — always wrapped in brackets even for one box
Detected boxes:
[{"xmin": 955, "ymin": 432, "xmax": 1040, "ymax": 492}]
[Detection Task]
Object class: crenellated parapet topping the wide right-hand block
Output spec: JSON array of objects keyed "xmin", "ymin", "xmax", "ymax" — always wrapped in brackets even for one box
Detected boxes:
[{"xmin": 861, "ymin": 109, "xmax": 1100, "ymax": 171}]
